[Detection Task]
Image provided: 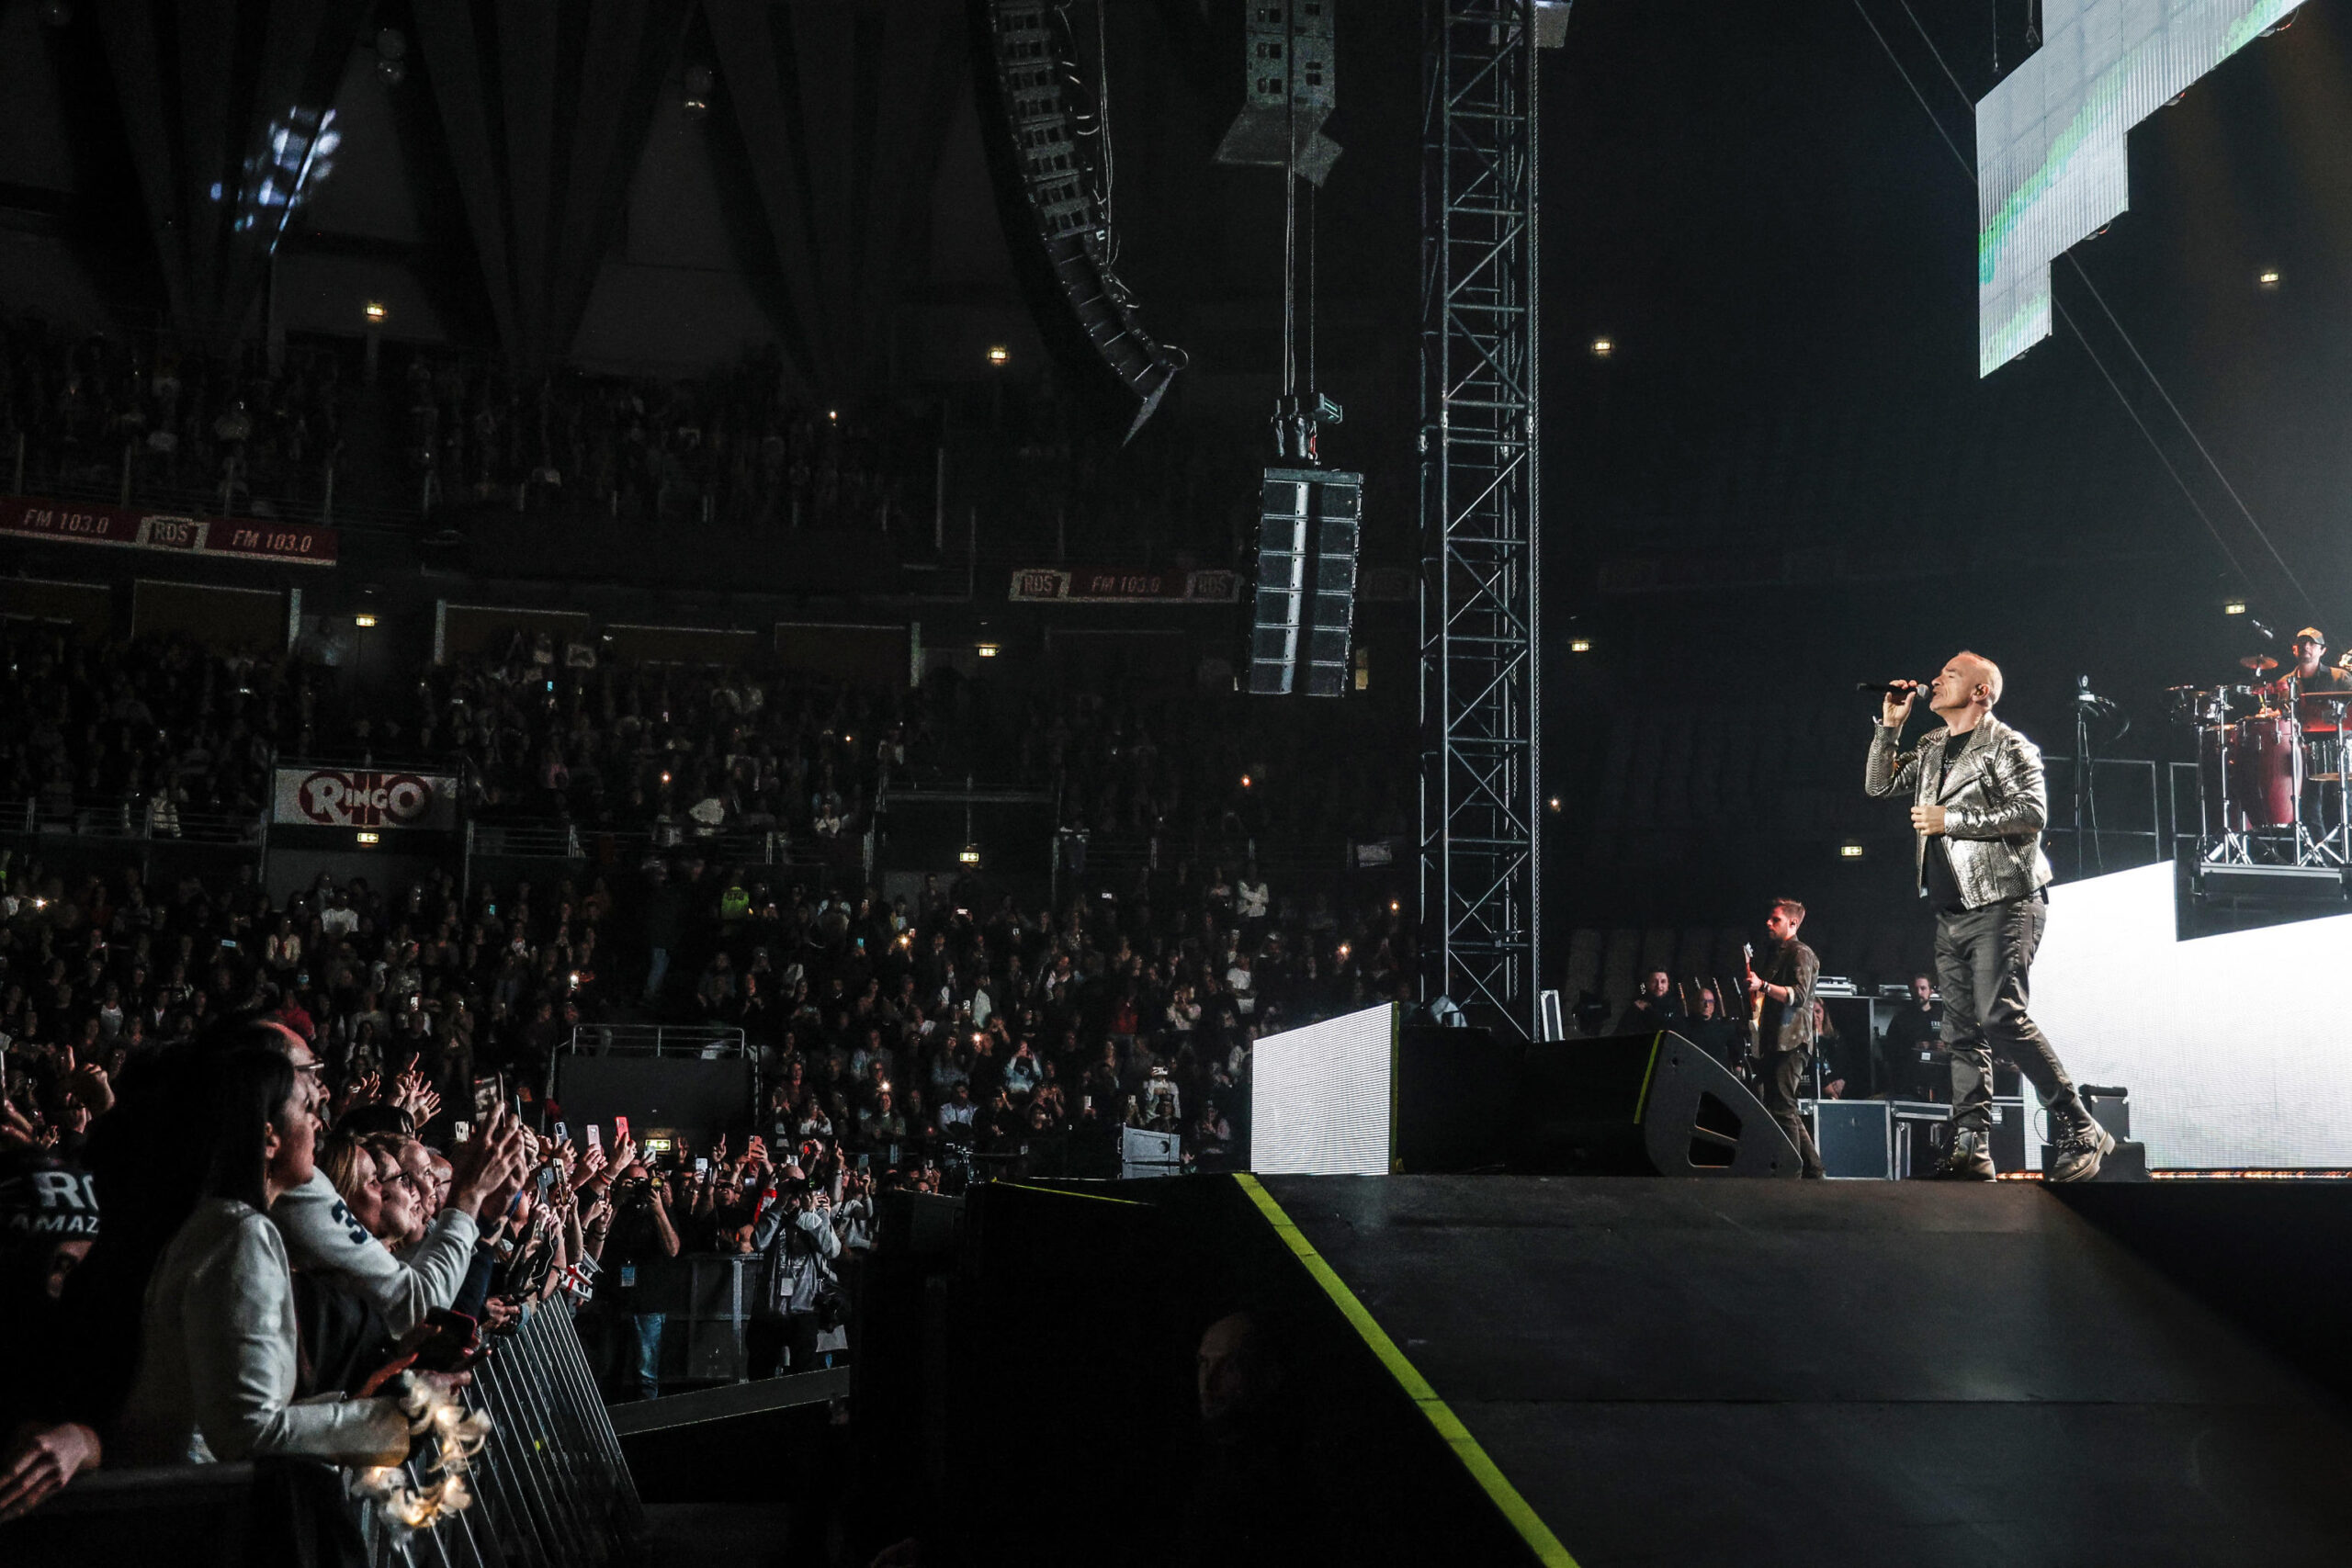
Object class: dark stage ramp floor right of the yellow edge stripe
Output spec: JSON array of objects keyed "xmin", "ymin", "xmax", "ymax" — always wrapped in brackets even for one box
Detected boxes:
[{"xmin": 1263, "ymin": 1176, "xmax": 2352, "ymax": 1568}]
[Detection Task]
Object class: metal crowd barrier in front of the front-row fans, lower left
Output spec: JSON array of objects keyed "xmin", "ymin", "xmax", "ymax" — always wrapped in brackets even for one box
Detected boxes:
[{"xmin": 362, "ymin": 1298, "xmax": 644, "ymax": 1568}]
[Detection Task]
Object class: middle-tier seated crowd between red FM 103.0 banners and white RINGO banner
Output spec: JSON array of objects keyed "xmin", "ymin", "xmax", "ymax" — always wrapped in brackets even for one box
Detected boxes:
[{"xmin": 0, "ymin": 623, "xmax": 1411, "ymax": 879}]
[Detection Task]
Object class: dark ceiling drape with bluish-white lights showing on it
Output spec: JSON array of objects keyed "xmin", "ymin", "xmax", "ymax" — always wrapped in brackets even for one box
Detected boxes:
[{"xmin": 89, "ymin": 0, "xmax": 369, "ymax": 345}]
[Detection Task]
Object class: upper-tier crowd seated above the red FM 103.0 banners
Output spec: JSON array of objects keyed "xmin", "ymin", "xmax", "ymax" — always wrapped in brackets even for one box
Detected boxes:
[{"xmin": 0, "ymin": 312, "xmax": 1259, "ymax": 562}]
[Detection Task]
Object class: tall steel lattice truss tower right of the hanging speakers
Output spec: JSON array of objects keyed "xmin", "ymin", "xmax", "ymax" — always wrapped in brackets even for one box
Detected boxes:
[{"xmin": 1420, "ymin": 0, "xmax": 1543, "ymax": 1039}]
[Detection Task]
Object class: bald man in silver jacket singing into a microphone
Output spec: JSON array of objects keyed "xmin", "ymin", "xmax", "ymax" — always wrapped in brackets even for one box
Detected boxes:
[{"xmin": 1863, "ymin": 653, "xmax": 2114, "ymax": 1182}]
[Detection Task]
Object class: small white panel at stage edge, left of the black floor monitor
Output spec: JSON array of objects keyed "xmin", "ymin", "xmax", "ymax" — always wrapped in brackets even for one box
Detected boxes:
[{"xmin": 1249, "ymin": 1004, "xmax": 1397, "ymax": 1176}]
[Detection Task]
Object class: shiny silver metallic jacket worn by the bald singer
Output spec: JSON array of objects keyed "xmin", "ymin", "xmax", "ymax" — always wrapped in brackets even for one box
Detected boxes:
[{"xmin": 1863, "ymin": 712, "xmax": 2053, "ymax": 909}]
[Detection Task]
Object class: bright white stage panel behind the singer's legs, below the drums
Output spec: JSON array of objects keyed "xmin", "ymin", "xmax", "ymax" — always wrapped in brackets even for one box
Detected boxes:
[{"xmin": 2028, "ymin": 865, "xmax": 2352, "ymax": 1168}]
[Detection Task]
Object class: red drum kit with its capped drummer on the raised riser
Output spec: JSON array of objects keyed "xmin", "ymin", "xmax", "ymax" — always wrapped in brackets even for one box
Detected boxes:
[{"xmin": 2171, "ymin": 653, "xmax": 2352, "ymax": 867}]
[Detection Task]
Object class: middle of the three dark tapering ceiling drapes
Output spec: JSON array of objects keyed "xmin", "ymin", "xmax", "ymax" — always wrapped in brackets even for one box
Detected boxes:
[{"xmin": 412, "ymin": 0, "xmax": 694, "ymax": 369}]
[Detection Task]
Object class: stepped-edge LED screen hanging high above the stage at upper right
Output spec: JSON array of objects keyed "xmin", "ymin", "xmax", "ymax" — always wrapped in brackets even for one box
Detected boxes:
[{"xmin": 1975, "ymin": 0, "xmax": 2302, "ymax": 376}]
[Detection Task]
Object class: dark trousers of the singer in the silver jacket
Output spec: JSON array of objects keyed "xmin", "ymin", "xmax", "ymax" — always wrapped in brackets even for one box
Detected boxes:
[{"xmin": 1936, "ymin": 894, "xmax": 2086, "ymax": 1138}]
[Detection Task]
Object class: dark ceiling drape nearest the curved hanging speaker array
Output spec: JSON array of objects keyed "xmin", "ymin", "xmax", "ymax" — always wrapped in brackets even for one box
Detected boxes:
[{"xmin": 703, "ymin": 0, "xmax": 971, "ymax": 398}]
